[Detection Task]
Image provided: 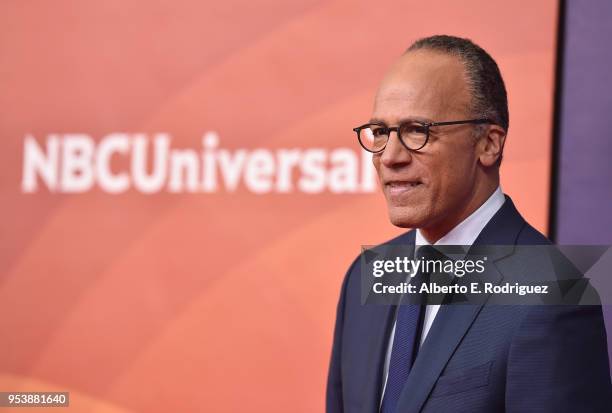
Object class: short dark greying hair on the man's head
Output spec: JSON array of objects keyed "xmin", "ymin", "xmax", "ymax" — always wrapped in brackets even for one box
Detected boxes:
[{"xmin": 406, "ymin": 35, "xmax": 510, "ymax": 133}]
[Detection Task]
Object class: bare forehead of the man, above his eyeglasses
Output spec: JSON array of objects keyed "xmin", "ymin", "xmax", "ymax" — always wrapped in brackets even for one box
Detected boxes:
[{"xmin": 372, "ymin": 50, "xmax": 470, "ymax": 124}]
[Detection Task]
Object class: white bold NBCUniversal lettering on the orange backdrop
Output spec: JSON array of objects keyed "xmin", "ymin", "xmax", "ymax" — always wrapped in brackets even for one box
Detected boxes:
[{"xmin": 21, "ymin": 131, "xmax": 377, "ymax": 194}]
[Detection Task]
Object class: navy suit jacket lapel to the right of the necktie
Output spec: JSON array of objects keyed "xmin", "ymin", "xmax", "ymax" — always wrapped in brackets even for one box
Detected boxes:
[{"xmin": 394, "ymin": 196, "xmax": 525, "ymax": 413}]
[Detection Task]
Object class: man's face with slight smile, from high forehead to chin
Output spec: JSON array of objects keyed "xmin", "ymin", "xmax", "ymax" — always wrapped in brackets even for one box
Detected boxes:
[{"xmin": 372, "ymin": 50, "xmax": 486, "ymax": 228}]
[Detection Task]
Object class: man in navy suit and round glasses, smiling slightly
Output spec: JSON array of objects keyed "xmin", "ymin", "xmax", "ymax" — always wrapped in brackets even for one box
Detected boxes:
[{"xmin": 327, "ymin": 36, "xmax": 612, "ymax": 413}]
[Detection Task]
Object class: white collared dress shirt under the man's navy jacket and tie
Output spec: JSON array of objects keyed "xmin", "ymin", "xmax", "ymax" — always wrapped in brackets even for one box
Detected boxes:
[{"xmin": 380, "ymin": 186, "xmax": 506, "ymax": 403}]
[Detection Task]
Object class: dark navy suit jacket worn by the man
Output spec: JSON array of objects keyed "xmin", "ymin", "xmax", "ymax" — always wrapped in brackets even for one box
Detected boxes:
[{"xmin": 327, "ymin": 197, "xmax": 612, "ymax": 413}]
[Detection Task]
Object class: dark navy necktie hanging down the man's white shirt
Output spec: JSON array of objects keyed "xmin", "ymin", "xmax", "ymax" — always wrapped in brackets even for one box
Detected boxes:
[{"xmin": 380, "ymin": 246, "xmax": 433, "ymax": 413}]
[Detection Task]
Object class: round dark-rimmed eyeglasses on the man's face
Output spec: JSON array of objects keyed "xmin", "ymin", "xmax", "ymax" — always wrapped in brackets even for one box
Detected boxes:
[{"xmin": 353, "ymin": 119, "xmax": 493, "ymax": 153}]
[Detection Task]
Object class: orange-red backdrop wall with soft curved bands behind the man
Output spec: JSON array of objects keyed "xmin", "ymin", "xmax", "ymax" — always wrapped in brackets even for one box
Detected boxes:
[{"xmin": 0, "ymin": 0, "xmax": 557, "ymax": 412}]
